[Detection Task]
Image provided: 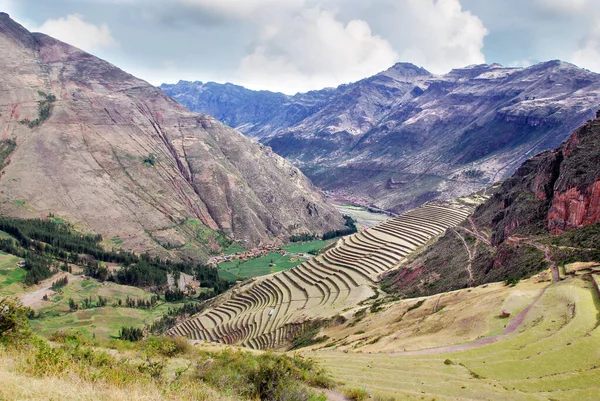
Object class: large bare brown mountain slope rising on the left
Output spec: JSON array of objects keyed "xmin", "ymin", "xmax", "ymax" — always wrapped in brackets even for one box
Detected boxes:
[{"xmin": 0, "ymin": 13, "xmax": 344, "ymax": 259}]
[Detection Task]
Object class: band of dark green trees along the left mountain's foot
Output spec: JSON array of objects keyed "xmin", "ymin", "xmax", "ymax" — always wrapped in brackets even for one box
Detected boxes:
[{"xmin": 0, "ymin": 216, "xmax": 231, "ymax": 294}]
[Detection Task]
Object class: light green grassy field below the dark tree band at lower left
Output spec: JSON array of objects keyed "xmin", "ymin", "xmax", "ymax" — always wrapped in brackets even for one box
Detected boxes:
[{"xmin": 31, "ymin": 279, "xmax": 183, "ymax": 338}]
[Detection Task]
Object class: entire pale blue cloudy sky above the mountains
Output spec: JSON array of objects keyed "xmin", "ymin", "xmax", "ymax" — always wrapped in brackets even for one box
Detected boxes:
[{"xmin": 0, "ymin": 0, "xmax": 600, "ymax": 94}]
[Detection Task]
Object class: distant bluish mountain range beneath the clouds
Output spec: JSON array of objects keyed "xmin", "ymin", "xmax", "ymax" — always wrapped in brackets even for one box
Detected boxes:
[{"xmin": 161, "ymin": 61, "xmax": 600, "ymax": 211}]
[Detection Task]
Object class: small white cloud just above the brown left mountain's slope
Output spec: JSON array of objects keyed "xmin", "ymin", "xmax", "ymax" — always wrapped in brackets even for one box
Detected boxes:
[{"xmin": 36, "ymin": 14, "xmax": 119, "ymax": 52}]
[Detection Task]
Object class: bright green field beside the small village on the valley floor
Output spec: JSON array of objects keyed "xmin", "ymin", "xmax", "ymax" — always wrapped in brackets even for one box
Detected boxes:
[{"xmin": 218, "ymin": 252, "xmax": 305, "ymax": 281}]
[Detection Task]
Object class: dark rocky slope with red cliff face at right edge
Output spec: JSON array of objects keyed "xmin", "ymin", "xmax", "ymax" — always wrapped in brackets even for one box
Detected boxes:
[{"xmin": 386, "ymin": 112, "xmax": 600, "ymax": 296}]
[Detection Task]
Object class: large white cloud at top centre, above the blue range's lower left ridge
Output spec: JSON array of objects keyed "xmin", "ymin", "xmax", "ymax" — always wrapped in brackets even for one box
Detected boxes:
[{"xmin": 237, "ymin": 7, "xmax": 398, "ymax": 93}]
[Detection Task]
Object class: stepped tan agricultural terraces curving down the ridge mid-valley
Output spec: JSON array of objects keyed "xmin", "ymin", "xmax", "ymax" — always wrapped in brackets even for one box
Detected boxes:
[{"xmin": 169, "ymin": 201, "xmax": 477, "ymax": 349}]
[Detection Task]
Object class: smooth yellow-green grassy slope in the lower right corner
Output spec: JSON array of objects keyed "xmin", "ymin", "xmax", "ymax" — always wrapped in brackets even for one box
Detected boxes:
[{"xmin": 307, "ymin": 278, "xmax": 600, "ymax": 400}]
